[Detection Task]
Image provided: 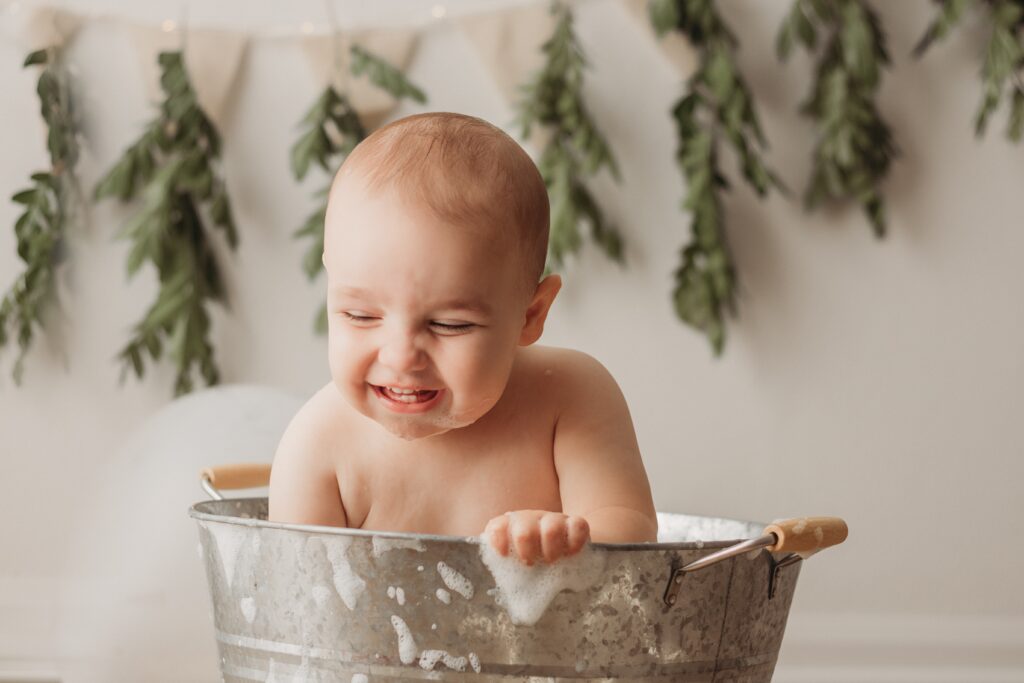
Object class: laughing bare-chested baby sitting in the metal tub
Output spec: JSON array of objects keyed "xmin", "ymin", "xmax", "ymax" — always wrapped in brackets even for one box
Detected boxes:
[{"xmin": 269, "ymin": 114, "xmax": 657, "ymax": 564}]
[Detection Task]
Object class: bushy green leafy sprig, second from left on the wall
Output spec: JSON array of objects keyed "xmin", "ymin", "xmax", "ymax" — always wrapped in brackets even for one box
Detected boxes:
[{"xmin": 95, "ymin": 52, "xmax": 238, "ymax": 395}]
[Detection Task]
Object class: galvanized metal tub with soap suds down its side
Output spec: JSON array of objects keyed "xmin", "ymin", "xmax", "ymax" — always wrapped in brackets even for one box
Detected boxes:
[{"xmin": 189, "ymin": 498, "xmax": 823, "ymax": 683}]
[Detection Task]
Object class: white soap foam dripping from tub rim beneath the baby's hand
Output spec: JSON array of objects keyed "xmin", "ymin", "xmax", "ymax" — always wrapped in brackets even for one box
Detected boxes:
[{"xmin": 480, "ymin": 541, "xmax": 605, "ymax": 626}]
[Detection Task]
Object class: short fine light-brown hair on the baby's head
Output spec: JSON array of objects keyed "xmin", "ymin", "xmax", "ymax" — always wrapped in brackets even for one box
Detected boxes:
[{"xmin": 338, "ymin": 112, "xmax": 550, "ymax": 286}]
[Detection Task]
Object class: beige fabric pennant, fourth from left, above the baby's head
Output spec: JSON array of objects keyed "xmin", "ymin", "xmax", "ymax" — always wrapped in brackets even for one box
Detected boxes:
[{"xmin": 455, "ymin": 3, "xmax": 555, "ymax": 150}]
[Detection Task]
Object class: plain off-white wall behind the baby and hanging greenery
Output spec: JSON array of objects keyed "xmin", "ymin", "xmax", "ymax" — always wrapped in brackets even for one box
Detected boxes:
[{"xmin": 0, "ymin": 0, "xmax": 1024, "ymax": 681}]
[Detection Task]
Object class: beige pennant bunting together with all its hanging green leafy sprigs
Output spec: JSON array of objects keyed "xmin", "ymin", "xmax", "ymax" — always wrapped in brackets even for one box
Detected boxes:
[{"xmin": 0, "ymin": 0, "xmax": 1024, "ymax": 393}]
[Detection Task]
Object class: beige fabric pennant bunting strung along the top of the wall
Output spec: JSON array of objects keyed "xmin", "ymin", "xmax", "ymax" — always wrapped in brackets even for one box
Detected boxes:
[{"xmin": 9, "ymin": 0, "xmax": 696, "ymax": 138}]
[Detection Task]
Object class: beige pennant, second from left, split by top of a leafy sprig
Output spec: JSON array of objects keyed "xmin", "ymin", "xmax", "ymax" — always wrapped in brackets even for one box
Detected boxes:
[{"xmin": 127, "ymin": 24, "xmax": 249, "ymax": 130}]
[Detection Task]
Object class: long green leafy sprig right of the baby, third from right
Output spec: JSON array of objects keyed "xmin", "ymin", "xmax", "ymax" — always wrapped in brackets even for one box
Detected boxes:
[{"xmin": 648, "ymin": 0, "xmax": 782, "ymax": 354}]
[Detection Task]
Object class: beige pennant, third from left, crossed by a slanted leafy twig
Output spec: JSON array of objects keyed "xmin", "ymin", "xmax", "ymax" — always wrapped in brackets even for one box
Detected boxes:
[{"xmin": 301, "ymin": 29, "xmax": 420, "ymax": 130}]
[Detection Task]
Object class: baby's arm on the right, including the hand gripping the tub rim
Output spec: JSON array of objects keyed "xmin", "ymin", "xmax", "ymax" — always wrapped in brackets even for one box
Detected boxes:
[{"xmin": 486, "ymin": 350, "xmax": 657, "ymax": 564}]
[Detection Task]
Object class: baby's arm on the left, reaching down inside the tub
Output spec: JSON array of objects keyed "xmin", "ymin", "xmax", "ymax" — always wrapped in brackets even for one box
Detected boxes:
[{"xmin": 267, "ymin": 386, "xmax": 348, "ymax": 526}]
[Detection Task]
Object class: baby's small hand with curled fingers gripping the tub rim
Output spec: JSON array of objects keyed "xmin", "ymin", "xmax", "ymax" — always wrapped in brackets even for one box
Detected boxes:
[{"xmin": 483, "ymin": 510, "xmax": 590, "ymax": 565}]
